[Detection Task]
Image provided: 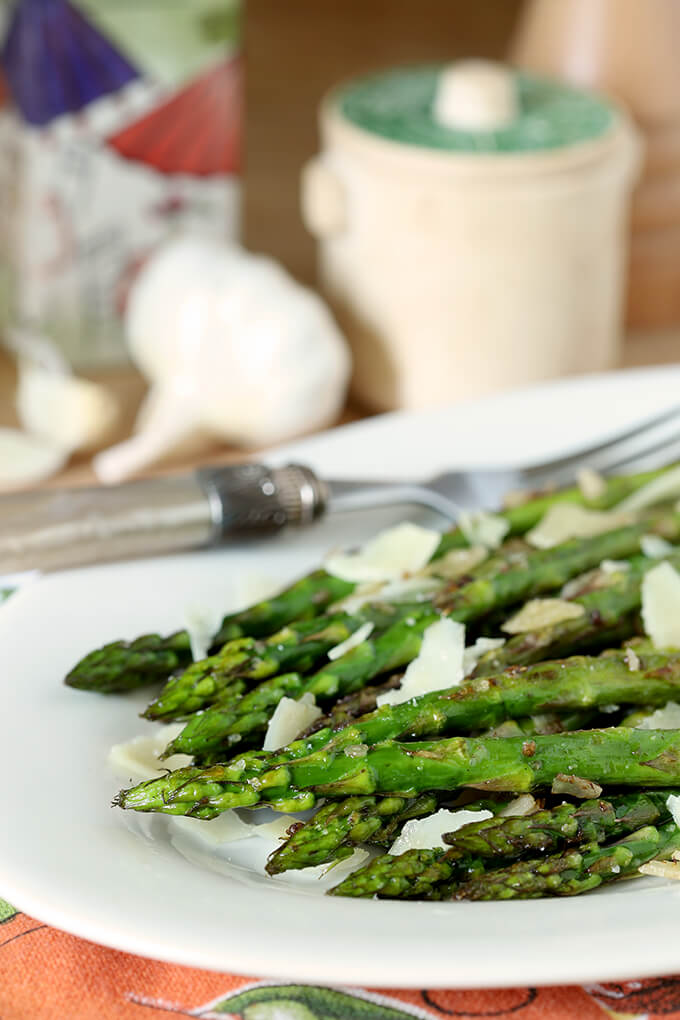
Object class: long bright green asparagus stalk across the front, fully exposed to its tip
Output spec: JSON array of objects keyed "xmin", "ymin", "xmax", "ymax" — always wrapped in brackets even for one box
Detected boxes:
[{"xmin": 115, "ymin": 726, "xmax": 680, "ymax": 818}]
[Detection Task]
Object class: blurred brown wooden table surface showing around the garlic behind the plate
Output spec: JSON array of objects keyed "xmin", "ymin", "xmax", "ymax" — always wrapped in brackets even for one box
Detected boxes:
[{"xmin": 0, "ymin": 328, "xmax": 680, "ymax": 488}]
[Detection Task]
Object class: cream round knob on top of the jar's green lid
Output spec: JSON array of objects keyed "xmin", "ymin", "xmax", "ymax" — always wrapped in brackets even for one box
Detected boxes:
[{"xmin": 432, "ymin": 60, "xmax": 520, "ymax": 132}]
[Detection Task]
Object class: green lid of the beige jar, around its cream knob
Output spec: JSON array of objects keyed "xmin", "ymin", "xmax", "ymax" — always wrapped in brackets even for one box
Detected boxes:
[{"xmin": 333, "ymin": 64, "xmax": 615, "ymax": 153}]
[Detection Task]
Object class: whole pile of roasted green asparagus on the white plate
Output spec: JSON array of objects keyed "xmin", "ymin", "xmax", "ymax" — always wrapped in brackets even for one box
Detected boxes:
[{"xmin": 66, "ymin": 472, "xmax": 680, "ymax": 900}]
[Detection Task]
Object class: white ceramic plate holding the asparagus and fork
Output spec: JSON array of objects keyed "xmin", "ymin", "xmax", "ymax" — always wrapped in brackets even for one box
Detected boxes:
[{"xmin": 0, "ymin": 367, "xmax": 680, "ymax": 987}]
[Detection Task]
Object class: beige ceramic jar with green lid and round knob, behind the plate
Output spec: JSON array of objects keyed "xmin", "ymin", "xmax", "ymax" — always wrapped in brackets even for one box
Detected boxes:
[{"xmin": 302, "ymin": 61, "xmax": 639, "ymax": 410}]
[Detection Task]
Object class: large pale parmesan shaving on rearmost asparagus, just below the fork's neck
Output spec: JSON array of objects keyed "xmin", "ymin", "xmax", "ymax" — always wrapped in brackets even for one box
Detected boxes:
[{"xmin": 324, "ymin": 522, "xmax": 441, "ymax": 581}]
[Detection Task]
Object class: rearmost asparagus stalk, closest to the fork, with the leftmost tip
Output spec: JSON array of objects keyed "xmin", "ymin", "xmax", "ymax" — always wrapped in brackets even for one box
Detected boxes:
[{"xmin": 65, "ymin": 468, "xmax": 669, "ymax": 693}]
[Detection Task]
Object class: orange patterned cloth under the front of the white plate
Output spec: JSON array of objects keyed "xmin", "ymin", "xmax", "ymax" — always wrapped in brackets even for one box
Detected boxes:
[{"xmin": 0, "ymin": 900, "xmax": 680, "ymax": 1020}]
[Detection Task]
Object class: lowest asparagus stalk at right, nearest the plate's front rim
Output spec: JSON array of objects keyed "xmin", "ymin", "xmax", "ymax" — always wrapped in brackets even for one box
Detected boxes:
[{"xmin": 446, "ymin": 822, "xmax": 680, "ymax": 900}]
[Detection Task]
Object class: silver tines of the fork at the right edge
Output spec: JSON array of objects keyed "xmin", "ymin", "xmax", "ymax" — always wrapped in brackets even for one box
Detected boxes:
[{"xmin": 524, "ymin": 406, "xmax": 680, "ymax": 486}]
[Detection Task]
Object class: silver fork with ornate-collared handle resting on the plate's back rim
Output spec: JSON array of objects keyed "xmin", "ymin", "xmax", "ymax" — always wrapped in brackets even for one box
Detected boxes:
[{"xmin": 0, "ymin": 397, "xmax": 680, "ymax": 573}]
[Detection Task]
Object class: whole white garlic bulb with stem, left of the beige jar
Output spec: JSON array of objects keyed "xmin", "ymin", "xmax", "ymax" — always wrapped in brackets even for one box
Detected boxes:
[{"xmin": 94, "ymin": 237, "xmax": 351, "ymax": 481}]
